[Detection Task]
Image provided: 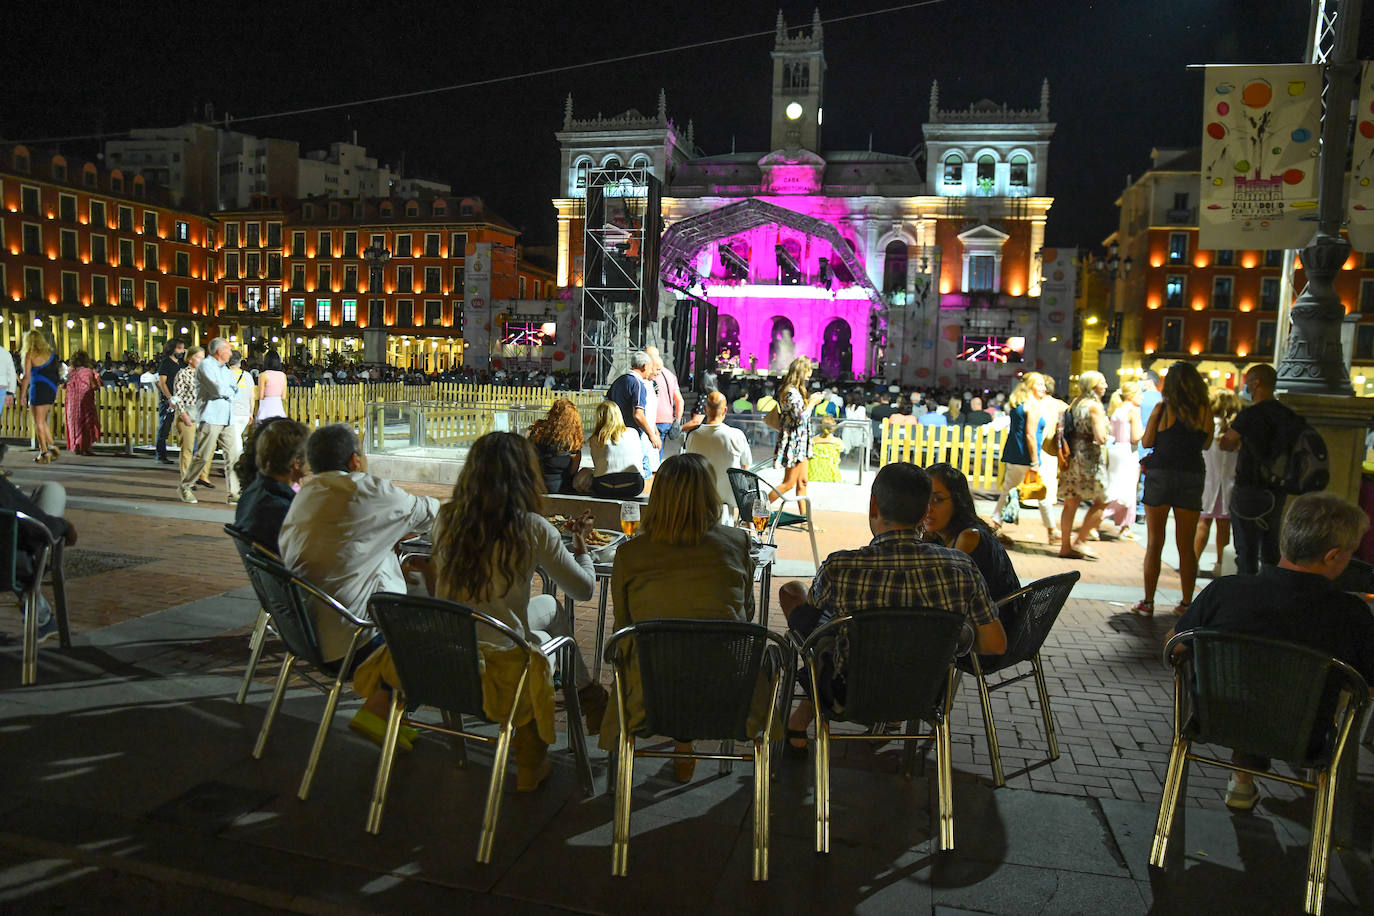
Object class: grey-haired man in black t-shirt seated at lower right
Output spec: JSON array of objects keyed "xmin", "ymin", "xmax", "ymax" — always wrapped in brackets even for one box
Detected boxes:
[{"xmin": 1173, "ymin": 493, "xmax": 1374, "ymax": 812}]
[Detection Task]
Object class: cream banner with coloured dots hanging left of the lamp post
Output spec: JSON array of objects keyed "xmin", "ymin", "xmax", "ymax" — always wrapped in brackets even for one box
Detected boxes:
[{"xmin": 1198, "ymin": 63, "xmax": 1322, "ymax": 250}]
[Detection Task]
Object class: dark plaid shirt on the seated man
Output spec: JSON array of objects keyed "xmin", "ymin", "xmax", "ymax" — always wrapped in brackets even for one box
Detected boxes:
[{"xmin": 811, "ymin": 529, "xmax": 998, "ymax": 673}]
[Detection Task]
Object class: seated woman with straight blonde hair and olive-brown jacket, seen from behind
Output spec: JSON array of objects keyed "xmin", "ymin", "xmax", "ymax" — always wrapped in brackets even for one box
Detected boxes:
[{"xmin": 600, "ymin": 450, "xmax": 767, "ymax": 783}]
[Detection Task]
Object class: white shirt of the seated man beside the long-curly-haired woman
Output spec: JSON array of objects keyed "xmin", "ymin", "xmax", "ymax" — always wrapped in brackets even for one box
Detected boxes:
[{"xmin": 278, "ymin": 471, "xmax": 438, "ymax": 659}]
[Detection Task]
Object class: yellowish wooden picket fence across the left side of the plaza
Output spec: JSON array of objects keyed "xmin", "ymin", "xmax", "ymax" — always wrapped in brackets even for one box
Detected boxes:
[{"xmin": 0, "ymin": 382, "xmax": 603, "ymax": 455}]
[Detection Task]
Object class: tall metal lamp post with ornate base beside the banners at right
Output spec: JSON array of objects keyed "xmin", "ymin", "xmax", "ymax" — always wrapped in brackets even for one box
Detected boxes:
[{"xmin": 1278, "ymin": 0, "xmax": 1362, "ymax": 397}]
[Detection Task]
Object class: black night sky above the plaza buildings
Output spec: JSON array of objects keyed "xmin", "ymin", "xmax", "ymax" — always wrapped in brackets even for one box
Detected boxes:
[{"xmin": 10, "ymin": 0, "xmax": 1374, "ymax": 254}]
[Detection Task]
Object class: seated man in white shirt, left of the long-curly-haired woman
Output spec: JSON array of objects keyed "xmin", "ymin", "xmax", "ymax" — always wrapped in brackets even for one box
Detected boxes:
[{"xmin": 278, "ymin": 423, "xmax": 438, "ymax": 750}]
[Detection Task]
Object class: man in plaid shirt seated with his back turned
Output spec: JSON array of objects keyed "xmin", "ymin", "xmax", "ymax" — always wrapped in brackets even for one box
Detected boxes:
[{"xmin": 778, "ymin": 461, "xmax": 1007, "ymax": 753}]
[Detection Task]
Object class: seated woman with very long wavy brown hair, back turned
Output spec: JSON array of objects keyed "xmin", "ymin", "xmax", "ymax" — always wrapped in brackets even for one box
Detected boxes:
[{"xmin": 431, "ymin": 433, "xmax": 607, "ymax": 792}]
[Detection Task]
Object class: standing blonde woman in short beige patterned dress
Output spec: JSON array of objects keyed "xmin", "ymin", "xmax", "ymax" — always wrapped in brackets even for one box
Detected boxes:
[{"xmin": 1059, "ymin": 369, "xmax": 1109, "ymax": 560}]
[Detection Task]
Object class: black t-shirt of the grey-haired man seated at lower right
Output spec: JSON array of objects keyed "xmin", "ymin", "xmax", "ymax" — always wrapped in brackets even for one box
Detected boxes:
[{"xmin": 1175, "ymin": 565, "xmax": 1374, "ymax": 683}]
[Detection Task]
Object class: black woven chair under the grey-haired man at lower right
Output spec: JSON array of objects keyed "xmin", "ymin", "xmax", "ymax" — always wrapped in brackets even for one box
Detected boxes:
[{"xmin": 1150, "ymin": 629, "xmax": 1370, "ymax": 916}]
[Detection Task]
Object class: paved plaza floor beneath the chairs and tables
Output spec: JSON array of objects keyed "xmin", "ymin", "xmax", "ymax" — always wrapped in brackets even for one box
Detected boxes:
[{"xmin": 0, "ymin": 452, "xmax": 1374, "ymax": 913}]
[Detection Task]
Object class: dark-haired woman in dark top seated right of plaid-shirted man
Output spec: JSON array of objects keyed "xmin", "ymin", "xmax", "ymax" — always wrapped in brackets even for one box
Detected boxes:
[{"xmin": 922, "ymin": 464, "xmax": 1024, "ymax": 642}]
